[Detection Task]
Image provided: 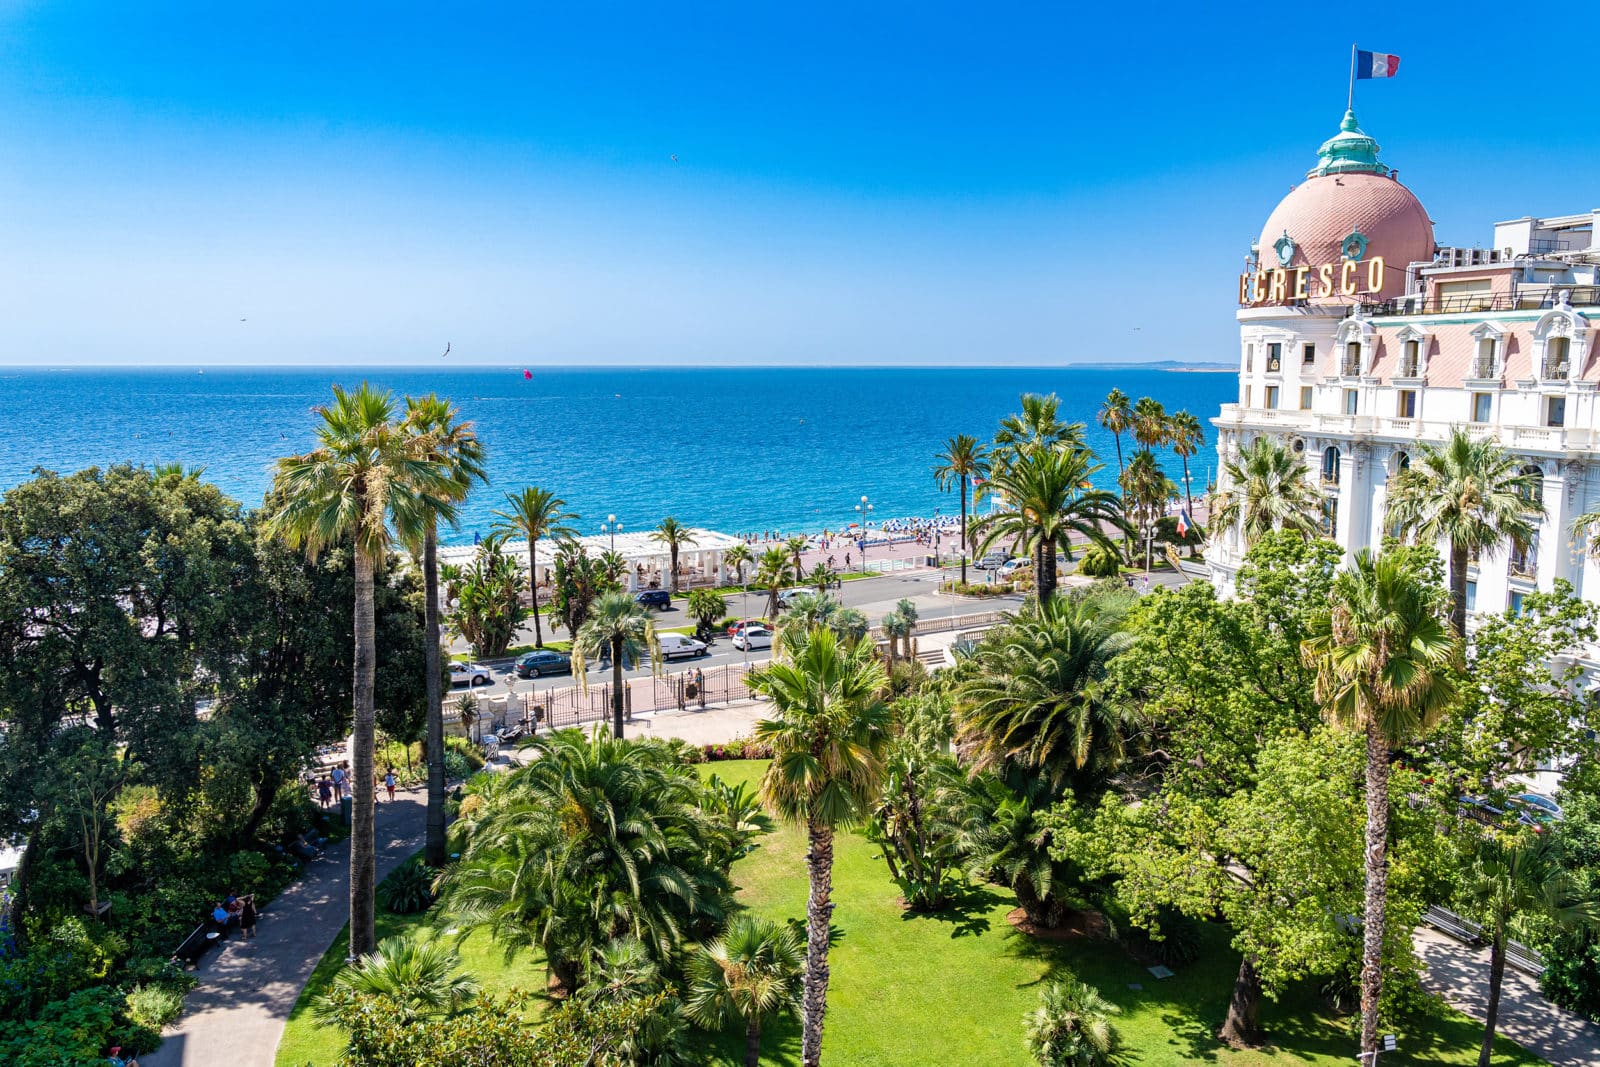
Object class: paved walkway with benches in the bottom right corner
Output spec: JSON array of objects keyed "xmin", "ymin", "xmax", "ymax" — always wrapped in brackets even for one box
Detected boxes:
[{"xmin": 1411, "ymin": 928, "xmax": 1600, "ymax": 1067}]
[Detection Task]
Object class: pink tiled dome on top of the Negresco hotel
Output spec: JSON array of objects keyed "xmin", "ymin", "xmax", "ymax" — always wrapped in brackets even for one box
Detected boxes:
[{"xmin": 1258, "ymin": 173, "xmax": 1434, "ymax": 304}]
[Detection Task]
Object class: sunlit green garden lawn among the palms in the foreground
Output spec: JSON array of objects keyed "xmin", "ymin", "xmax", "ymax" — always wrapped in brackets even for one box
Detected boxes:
[{"xmin": 277, "ymin": 760, "xmax": 1542, "ymax": 1067}]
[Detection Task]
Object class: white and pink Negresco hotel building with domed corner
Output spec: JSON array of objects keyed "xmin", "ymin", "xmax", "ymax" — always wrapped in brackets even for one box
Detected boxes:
[{"xmin": 1206, "ymin": 112, "xmax": 1600, "ymax": 627}]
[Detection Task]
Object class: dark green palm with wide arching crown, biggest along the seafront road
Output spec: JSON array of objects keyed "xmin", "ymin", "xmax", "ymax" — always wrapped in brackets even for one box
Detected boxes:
[{"xmin": 973, "ymin": 448, "xmax": 1126, "ymax": 600}]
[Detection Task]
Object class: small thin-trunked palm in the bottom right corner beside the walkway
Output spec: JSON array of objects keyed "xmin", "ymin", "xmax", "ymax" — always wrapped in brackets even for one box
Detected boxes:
[{"xmin": 1467, "ymin": 832, "xmax": 1600, "ymax": 1067}]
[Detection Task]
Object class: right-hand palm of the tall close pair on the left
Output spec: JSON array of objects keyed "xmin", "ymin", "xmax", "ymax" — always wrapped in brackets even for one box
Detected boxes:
[{"xmin": 406, "ymin": 394, "xmax": 488, "ymax": 867}]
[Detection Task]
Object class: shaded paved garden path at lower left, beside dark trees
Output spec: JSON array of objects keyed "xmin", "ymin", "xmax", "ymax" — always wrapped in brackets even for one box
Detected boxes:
[{"xmin": 139, "ymin": 787, "xmax": 427, "ymax": 1067}]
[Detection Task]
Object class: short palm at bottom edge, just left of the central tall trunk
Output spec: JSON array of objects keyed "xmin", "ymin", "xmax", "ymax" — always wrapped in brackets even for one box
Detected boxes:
[{"xmin": 683, "ymin": 912, "xmax": 805, "ymax": 1067}]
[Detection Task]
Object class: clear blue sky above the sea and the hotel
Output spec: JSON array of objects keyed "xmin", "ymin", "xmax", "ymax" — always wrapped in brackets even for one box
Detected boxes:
[{"xmin": 0, "ymin": 2, "xmax": 1574, "ymax": 365}]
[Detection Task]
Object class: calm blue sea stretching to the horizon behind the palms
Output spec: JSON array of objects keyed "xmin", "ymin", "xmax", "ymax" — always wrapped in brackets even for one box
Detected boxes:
[{"xmin": 0, "ymin": 368, "xmax": 1237, "ymax": 541}]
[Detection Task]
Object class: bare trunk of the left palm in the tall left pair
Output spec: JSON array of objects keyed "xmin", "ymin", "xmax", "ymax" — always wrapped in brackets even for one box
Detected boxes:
[{"xmin": 350, "ymin": 541, "xmax": 378, "ymax": 957}]
